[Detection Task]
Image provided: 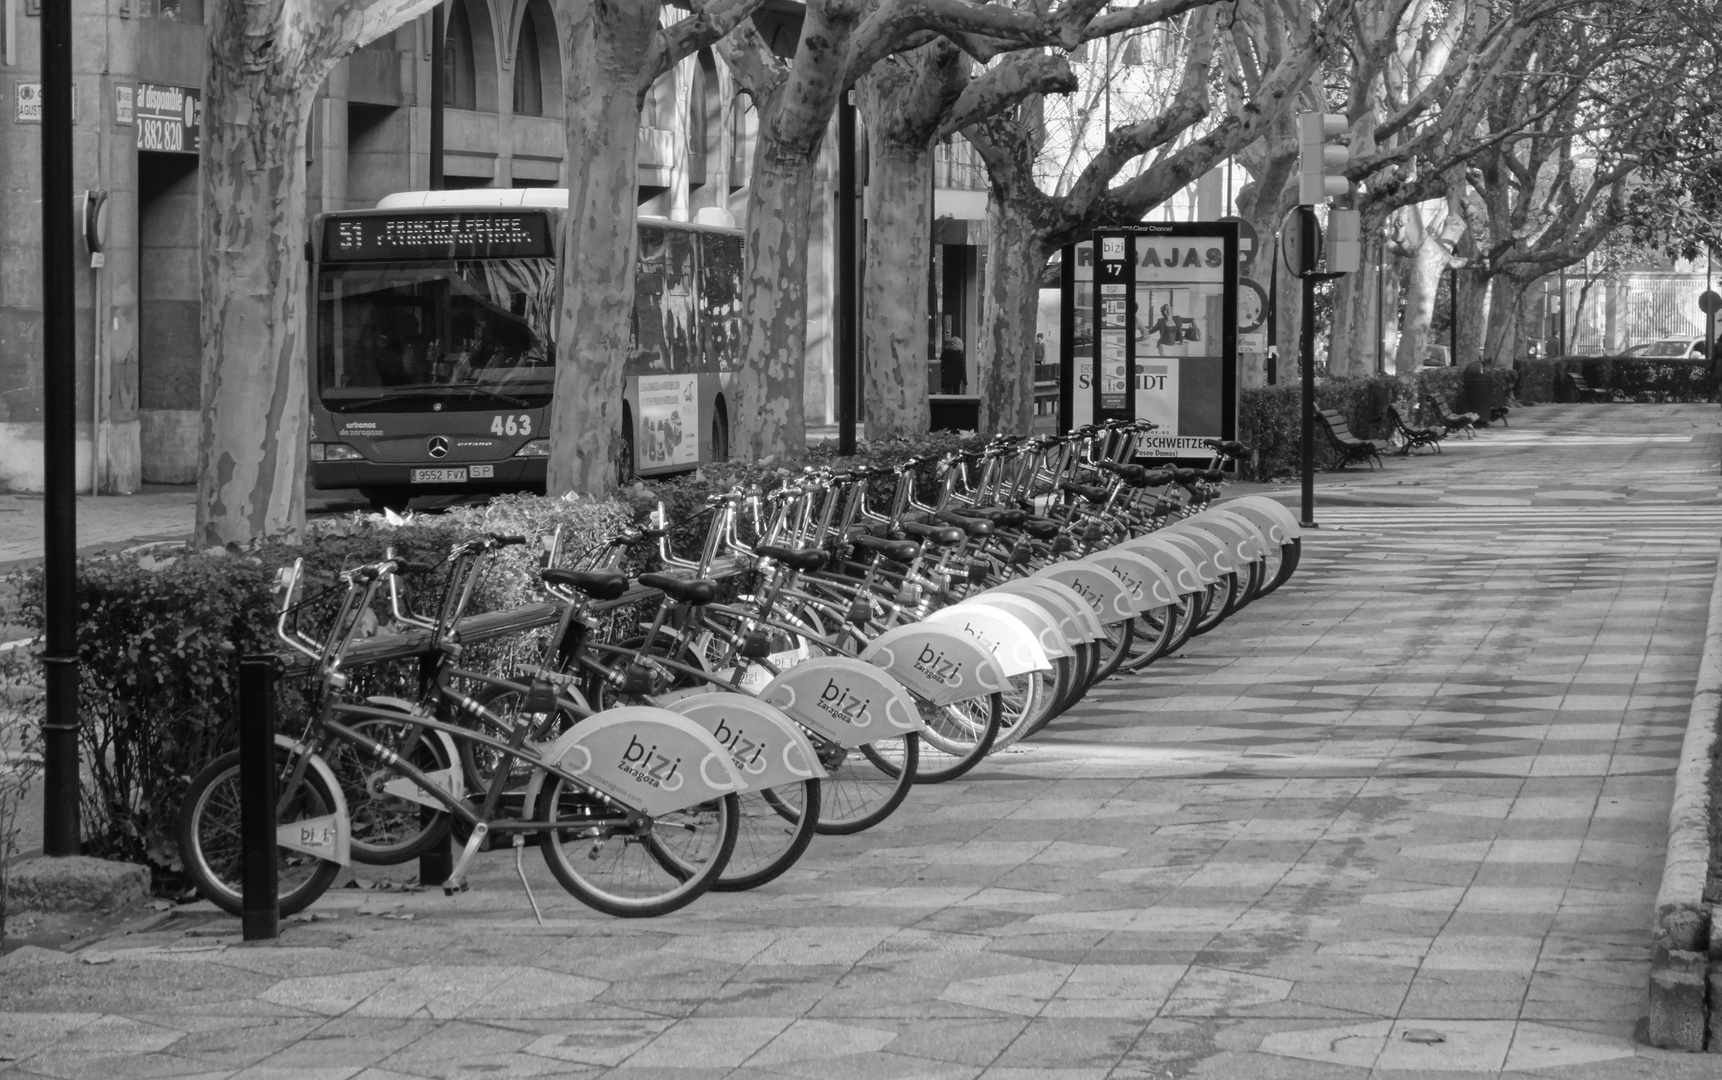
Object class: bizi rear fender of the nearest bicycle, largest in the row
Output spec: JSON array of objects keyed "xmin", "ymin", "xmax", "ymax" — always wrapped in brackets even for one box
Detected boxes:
[{"xmin": 529, "ymin": 704, "xmax": 747, "ymax": 816}]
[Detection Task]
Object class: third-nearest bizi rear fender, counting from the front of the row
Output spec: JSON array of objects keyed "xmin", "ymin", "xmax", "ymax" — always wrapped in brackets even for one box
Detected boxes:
[{"xmin": 759, "ymin": 656, "xmax": 926, "ymax": 748}]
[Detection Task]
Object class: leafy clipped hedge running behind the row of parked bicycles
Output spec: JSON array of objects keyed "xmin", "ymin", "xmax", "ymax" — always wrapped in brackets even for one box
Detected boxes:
[{"xmin": 0, "ymin": 434, "xmax": 975, "ymax": 887}]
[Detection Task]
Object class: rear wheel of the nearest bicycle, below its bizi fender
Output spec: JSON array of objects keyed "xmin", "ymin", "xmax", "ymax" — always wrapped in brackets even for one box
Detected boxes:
[{"xmin": 537, "ymin": 777, "xmax": 740, "ymax": 918}]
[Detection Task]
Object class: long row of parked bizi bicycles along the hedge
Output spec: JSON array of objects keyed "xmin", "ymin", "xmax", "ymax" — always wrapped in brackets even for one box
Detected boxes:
[{"xmin": 179, "ymin": 422, "xmax": 1300, "ymax": 916}]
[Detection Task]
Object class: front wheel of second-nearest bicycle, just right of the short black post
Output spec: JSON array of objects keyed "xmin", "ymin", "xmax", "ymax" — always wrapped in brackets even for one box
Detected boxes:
[{"xmin": 322, "ymin": 713, "xmax": 453, "ymax": 866}]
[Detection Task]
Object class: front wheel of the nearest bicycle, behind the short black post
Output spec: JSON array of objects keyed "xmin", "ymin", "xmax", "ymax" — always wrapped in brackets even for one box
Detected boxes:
[{"xmin": 176, "ymin": 746, "xmax": 341, "ymax": 916}]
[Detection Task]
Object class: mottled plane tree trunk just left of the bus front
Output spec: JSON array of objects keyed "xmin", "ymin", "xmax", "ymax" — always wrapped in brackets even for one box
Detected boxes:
[{"xmin": 195, "ymin": 0, "xmax": 436, "ymax": 546}]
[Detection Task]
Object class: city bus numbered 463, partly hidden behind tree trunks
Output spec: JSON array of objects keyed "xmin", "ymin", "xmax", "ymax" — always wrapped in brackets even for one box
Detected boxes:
[{"xmin": 308, "ymin": 188, "xmax": 742, "ymax": 508}]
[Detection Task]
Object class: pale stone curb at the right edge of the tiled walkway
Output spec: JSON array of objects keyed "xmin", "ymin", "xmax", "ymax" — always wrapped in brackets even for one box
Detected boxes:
[{"xmin": 1646, "ymin": 551, "xmax": 1722, "ymax": 1051}]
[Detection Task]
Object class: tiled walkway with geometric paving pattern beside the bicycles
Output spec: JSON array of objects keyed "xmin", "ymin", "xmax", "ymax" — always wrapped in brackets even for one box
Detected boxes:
[{"xmin": 0, "ymin": 407, "xmax": 1722, "ymax": 1080}]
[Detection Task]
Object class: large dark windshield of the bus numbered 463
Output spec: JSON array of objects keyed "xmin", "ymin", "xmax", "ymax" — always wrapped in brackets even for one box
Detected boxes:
[{"xmin": 317, "ymin": 258, "xmax": 560, "ymax": 410}]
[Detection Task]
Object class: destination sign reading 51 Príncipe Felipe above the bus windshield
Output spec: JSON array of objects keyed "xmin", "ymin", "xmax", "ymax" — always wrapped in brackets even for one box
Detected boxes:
[{"xmin": 324, "ymin": 210, "xmax": 554, "ymax": 262}]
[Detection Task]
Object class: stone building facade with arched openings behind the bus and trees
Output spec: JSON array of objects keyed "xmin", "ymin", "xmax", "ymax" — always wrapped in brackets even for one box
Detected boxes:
[{"xmin": 0, "ymin": 0, "xmax": 888, "ymax": 493}]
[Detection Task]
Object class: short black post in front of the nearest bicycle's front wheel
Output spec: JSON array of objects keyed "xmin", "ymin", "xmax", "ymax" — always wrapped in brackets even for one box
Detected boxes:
[{"xmin": 239, "ymin": 653, "xmax": 281, "ymax": 940}]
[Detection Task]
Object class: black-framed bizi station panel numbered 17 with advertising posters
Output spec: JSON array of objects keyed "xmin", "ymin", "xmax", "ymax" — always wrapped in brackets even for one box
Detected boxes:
[{"xmin": 1071, "ymin": 222, "xmax": 1238, "ymax": 458}]
